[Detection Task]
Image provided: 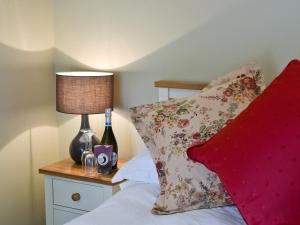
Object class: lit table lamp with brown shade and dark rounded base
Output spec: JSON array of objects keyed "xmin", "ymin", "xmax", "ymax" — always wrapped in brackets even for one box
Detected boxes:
[{"xmin": 56, "ymin": 71, "xmax": 114, "ymax": 164}]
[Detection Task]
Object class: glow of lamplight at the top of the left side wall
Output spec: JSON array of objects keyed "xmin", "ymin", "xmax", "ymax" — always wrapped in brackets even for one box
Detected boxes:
[{"xmin": 0, "ymin": 0, "xmax": 54, "ymax": 51}]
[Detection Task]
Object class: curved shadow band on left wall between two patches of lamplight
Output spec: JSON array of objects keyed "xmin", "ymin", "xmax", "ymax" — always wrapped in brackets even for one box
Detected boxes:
[{"xmin": 0, "ymin": 44, "xmax": 57, "ymax": 151}]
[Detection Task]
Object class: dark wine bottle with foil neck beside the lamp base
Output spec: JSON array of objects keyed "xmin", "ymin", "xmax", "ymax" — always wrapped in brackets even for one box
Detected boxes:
[{"xmin": 100, "ymin": 108, "xmax": 118, "ymax": 170}]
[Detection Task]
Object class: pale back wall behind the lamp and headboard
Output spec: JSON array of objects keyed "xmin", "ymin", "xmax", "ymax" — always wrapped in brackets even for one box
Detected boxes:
[{"xmin": 54, "ymin": 0, "xmax": 300, "ymax": 157}]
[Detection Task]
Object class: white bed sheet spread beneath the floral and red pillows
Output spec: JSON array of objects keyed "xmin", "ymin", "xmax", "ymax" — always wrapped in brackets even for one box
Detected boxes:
[{"xmin": 65, "ymin": 183, "xmax": 246, "ymax": 225}]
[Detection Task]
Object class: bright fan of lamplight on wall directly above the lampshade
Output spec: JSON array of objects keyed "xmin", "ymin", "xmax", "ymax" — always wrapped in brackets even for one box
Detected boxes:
[{"xmin": 54, "ymin": 0, "xmax": 240, "ymax": 70}]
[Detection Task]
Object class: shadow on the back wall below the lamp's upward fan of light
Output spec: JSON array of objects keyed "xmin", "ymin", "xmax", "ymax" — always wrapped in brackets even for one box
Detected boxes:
[{"xmin": 55, "ymin": 1, "xmax": 300, "ymax": 109}]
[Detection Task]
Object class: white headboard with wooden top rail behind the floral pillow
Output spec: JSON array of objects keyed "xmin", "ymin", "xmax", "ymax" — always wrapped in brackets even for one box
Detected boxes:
[{"xmin": 154, "ymin": 80, "xmax": 207, "ymax": 101}]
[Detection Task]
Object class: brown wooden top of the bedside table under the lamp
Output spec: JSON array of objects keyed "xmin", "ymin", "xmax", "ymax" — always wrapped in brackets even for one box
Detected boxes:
[{"xmin": 39, "ymin": 159, "xmax": 125, "ymax": 186}]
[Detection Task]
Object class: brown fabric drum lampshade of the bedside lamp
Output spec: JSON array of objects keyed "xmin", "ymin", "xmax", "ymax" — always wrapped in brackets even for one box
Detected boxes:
[{"xmin": 56, "ymin": 71, "xmax": 114, "ymax": 114}]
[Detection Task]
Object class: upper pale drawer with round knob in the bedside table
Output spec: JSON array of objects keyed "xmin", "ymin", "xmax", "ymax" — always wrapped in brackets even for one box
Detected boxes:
[{"xmin": 53, "ymin": 178, "xmax": 104, "ymax": 211}]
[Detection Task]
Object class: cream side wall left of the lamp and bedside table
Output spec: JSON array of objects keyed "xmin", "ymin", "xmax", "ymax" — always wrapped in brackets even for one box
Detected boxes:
[{"xmin": 0, "ymin": 0, "xmax": 58, "ymax": 225}]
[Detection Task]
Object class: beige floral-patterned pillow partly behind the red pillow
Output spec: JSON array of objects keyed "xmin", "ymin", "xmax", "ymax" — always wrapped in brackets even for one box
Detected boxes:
[{"xmin": 131, "ymin": 63, "xmax": 265, "ymax": 214}]
